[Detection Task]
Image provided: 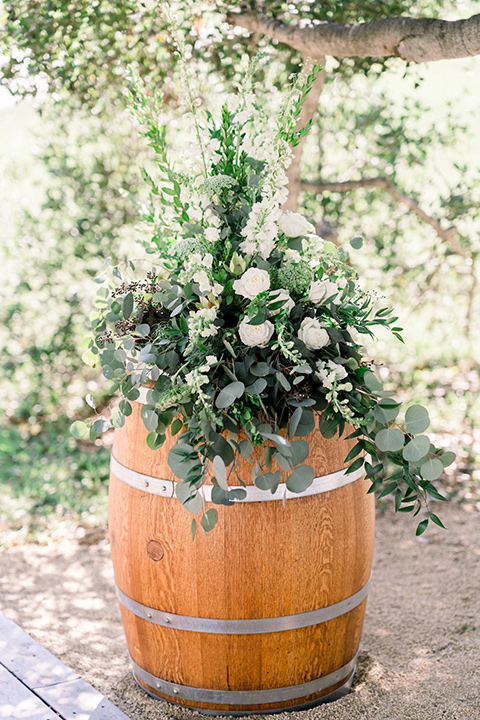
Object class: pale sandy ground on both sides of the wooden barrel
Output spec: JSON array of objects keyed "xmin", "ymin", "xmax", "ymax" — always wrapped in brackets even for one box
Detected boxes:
[{"xmin": 0, "ymin": 505, "xmax": 480, "ymax": 720}]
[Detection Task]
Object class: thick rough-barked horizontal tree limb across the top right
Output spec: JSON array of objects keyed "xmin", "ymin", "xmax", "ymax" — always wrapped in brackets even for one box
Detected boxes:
[{"xmin": 227, "ymin": 11, "xmax": 480, "ymax": 63}]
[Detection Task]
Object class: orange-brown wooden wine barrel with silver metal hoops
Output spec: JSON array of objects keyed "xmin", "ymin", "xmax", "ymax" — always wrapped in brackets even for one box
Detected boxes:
[{"xmin": 109, "ymin": 396, "xmax": 374, "ymax": 715}]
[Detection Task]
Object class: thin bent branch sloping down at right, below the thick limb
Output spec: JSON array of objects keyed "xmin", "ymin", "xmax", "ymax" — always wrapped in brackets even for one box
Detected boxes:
[{"xmin": 301, "ymin": 175, "xmax": 467, "ymax": 257}]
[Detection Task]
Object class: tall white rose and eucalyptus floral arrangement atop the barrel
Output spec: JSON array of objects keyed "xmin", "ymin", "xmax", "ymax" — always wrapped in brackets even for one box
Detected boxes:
[{"xmin": 72, "ymin": 56, "xmax": 455, "ymax": 534}]
